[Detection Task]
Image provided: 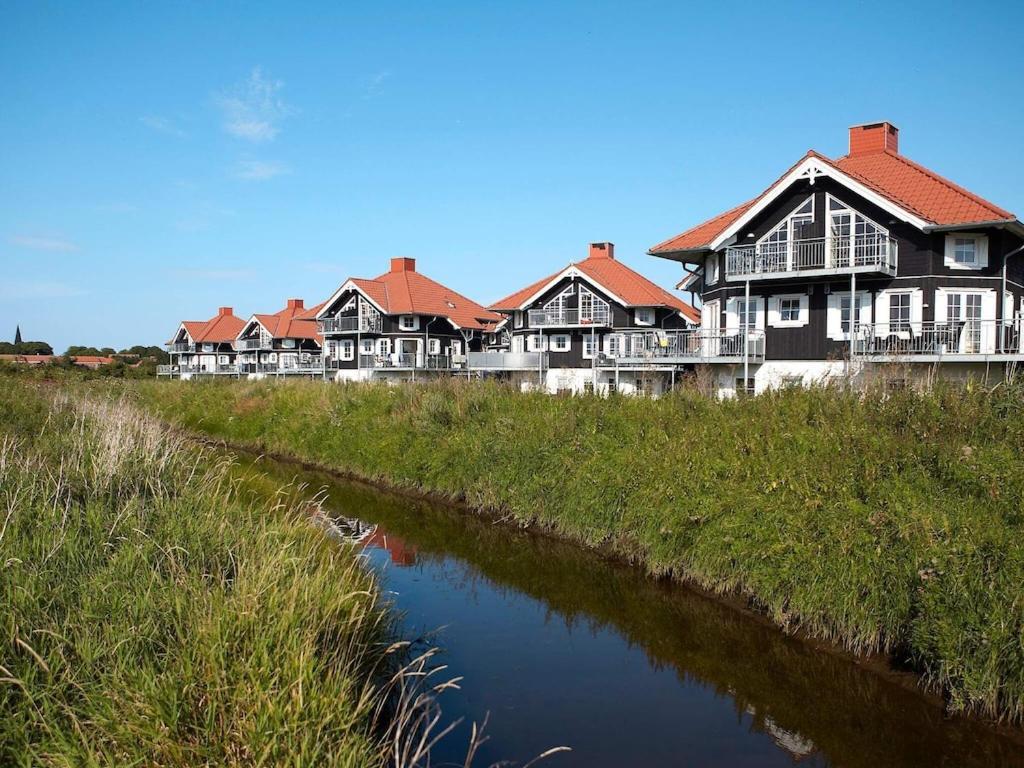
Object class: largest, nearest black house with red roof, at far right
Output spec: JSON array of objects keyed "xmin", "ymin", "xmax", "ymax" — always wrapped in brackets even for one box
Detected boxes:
[{"xmin": 649, "ymin": 122, "xmax": 1024, "ymax": 393}]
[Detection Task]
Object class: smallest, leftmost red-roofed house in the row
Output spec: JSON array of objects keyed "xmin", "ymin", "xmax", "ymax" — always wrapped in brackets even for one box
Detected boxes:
[{"xmin": 157, "ymin": 306, "xmax": 245, "ymax": 379}]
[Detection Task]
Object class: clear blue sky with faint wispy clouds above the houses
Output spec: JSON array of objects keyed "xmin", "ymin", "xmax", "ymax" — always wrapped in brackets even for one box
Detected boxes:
[{"xmin": 0, "ymin": 2, "xmax": 1024, "ymax": 351}]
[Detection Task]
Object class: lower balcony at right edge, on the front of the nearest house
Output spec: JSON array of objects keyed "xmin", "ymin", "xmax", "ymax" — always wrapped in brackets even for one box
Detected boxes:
[{"xmin": 852, "ymin": 318, "xmax": 1024, "ymax": 362}]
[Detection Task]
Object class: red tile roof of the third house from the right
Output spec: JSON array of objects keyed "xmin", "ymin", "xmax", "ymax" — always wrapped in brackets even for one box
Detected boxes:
[{"xmin": 347, "ymin": 259, "xmax": 502, "ymax": 331}]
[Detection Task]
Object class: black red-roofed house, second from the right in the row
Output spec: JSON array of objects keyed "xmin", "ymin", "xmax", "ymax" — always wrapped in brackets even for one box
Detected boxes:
[{"xmin": 479, "ymin": 243, "xmax": 700, "ymax": 394}]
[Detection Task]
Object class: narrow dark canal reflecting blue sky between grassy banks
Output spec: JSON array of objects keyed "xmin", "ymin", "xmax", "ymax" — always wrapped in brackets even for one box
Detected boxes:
[{"xmin": 238, "ymin": 457, "xmax": 1024, "ymax": 768}]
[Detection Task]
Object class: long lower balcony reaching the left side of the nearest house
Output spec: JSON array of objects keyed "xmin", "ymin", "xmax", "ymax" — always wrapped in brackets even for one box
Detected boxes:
[{"xmin": 601, "ymin": 329, "xmax": 765, "ymax": 368}]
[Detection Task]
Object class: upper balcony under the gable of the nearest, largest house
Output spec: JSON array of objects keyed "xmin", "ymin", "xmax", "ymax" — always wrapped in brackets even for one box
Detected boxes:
[{"xmin": 725, "ymin": 234, "xmax": 898, "ymax": 281}]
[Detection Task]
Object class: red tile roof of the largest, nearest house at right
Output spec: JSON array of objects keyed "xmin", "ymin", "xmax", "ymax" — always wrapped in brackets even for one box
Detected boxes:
[{"xmin": 648, "ymin": 143, "xmax": 1016, "ymax": 255}]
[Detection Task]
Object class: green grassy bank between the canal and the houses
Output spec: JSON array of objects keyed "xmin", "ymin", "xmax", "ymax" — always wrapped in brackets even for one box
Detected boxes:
[{"xmin": 131, "ymin": 381, "xmax": 1024, "ymax": 722}]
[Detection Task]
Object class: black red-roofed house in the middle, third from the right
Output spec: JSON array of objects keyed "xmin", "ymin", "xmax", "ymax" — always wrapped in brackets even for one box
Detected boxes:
[{"xmin": 316, "ymin": 258, "xmax": 502, "ymax": 380}]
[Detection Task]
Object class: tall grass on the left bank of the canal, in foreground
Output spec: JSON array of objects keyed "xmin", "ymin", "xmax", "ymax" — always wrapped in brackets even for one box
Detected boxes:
[{"xmin": 0, "ymin": 378, "xmax": 462, "ymax": 767}]
